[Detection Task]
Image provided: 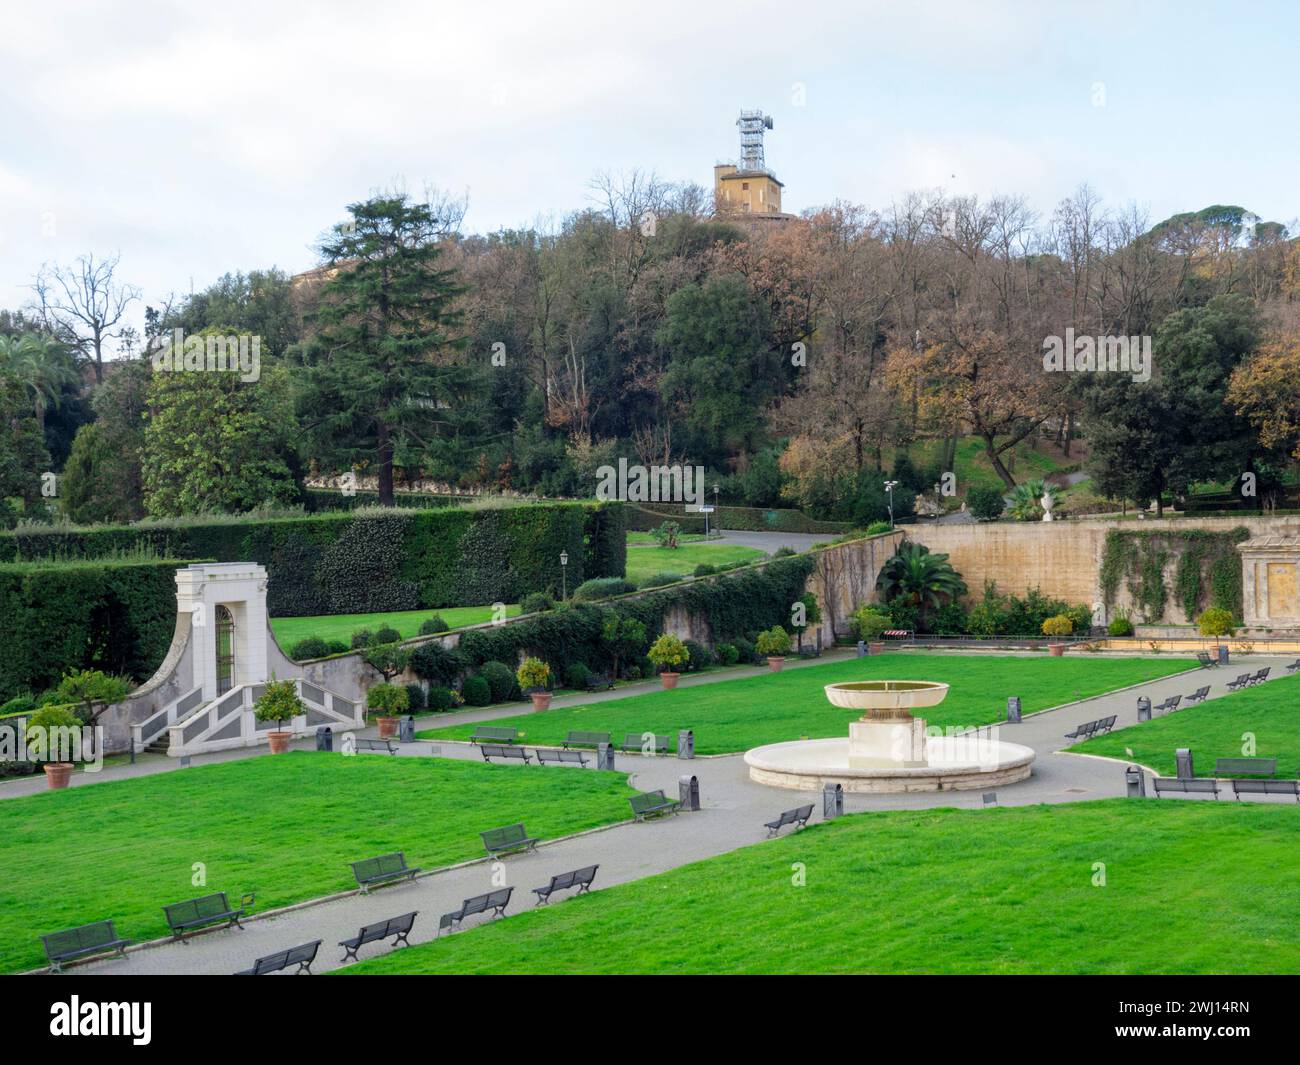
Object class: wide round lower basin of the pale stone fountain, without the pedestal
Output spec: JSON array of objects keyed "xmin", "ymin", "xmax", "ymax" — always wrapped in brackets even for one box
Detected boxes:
[{"xmin": 745, "ymin": 736, "xmax": 1034, "ymax": 792}]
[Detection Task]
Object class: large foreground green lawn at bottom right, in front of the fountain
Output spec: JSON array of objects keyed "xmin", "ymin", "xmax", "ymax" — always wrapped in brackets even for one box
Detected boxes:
[{"xmin": 343, "ymin": 793, "xmax": 1300, "ymax": 974}]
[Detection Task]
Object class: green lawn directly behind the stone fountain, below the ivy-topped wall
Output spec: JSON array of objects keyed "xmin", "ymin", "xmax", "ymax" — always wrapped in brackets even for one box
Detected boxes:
[{"xmin": 419, "ymin": 653, "xmax": 1188, "ymax": 754}]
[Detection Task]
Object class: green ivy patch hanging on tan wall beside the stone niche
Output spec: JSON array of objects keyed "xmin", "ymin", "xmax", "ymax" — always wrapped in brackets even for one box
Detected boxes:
[{"xmin": 1099, "ymin": 527, "xmax": 1251, "ymax": 623}]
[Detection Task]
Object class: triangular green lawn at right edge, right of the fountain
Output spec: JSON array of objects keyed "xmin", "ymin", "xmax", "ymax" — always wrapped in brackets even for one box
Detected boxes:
[{"xmin": 1070, "ymin": 676, "xmax": 1300, "ymax": 779}]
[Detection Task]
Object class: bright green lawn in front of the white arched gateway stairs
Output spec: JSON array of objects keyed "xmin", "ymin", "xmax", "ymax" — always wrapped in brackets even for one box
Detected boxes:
[{"xmin": 0, "ymin": 752, "xmax": 632, "ymax": 971}]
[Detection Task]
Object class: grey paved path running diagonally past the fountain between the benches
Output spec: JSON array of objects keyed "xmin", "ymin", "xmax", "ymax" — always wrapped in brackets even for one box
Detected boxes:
[{"xmin": 55, "ymin": 657, "xmax": 1284, "ymax": 975}]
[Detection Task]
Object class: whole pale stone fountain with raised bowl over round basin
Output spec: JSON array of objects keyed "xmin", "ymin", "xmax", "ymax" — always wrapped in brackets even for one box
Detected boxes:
[{"xmin": 745, "ymin": 680, "xmax": 1034, "ymax": 792}]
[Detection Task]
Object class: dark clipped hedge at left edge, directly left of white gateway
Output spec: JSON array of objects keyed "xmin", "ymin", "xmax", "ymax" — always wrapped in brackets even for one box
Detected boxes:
[{"xmin": 0, "ymin": 559, "xmax": 190, "ymax": 702}]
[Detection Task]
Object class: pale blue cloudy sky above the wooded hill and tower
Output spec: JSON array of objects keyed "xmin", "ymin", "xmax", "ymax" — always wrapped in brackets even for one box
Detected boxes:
[{"xmin": 0, "ymin": 0, "xmax": 1300, "ymax": 340}]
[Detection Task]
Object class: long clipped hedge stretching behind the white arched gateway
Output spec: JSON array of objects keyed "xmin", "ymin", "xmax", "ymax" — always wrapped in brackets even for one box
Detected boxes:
[{"xmin": 0, "ymin": 503, "xmax": 627, "ymax": 618}]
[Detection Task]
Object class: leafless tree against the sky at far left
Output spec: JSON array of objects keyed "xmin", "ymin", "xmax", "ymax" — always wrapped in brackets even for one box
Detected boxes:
[{"xmin": 31, "ymin": 255, "xmax": 140, "ymax": 381}]
